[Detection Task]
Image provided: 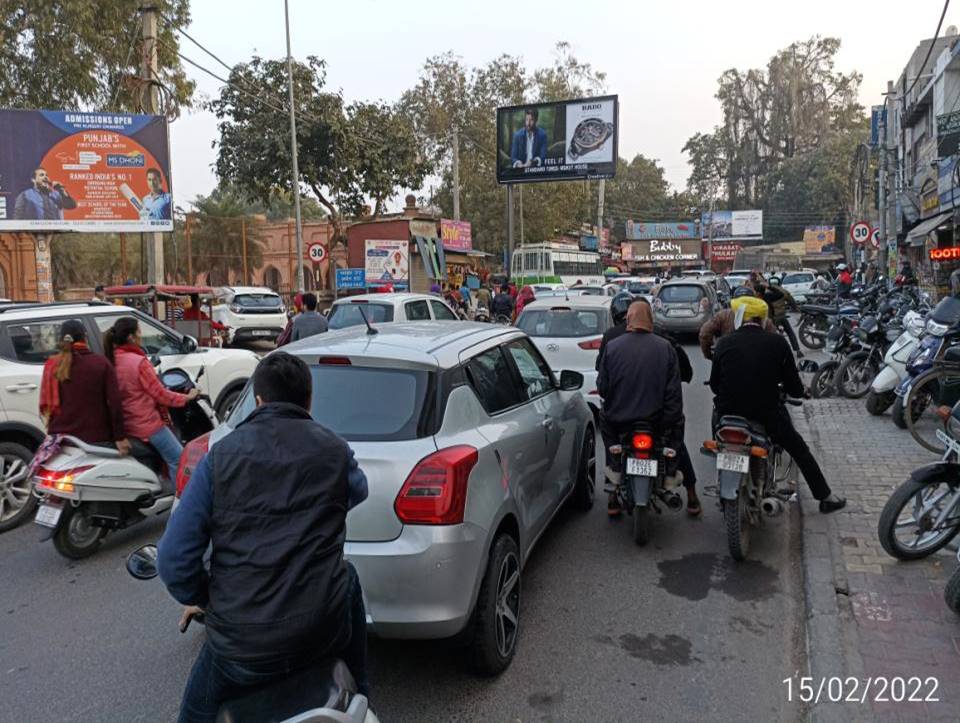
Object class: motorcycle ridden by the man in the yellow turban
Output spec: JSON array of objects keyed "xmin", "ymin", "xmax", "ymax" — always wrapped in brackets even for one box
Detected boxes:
[{"xmin": 700, "ymin": 399, "xmax": 801, "ymax": 561}]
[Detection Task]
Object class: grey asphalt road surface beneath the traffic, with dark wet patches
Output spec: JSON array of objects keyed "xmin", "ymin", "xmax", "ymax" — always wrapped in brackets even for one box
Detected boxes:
[{"xmin": 0, "ymin": 346, "xmax": 804, "ymax": 722}]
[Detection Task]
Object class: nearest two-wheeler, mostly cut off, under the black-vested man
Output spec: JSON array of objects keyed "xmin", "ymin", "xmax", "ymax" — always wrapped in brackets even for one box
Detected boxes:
[{"xmin": 127, "ymin": 545, "xmax": 379, "ymax": 723}]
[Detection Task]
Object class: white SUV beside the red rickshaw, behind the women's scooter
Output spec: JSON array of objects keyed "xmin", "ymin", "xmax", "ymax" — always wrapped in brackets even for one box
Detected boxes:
[{"xmin": 213, "ymin": 286, "xmax": 287, "ymax": 344}]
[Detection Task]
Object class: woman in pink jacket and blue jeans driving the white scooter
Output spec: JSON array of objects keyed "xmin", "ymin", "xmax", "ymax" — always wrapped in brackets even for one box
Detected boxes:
[{"xmin": 103, "ymin": 316, "xmax": 200, "ymax": 479}]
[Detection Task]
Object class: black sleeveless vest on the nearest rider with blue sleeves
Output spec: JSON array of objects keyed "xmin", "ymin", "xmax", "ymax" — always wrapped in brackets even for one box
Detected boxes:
[{"xmin": 207, "ymin": 403, "xmax": 350, "ymax": 660}]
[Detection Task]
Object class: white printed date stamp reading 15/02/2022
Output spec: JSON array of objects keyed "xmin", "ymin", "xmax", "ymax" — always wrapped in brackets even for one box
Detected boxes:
[{"xmin": 780, "ymin": 674, "xmax": 940, "ymax": 704}]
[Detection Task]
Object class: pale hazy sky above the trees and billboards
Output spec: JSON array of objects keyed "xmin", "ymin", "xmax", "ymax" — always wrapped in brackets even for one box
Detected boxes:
[{"xmin": 170, "ymin": 0, "xmax": 960, "ymax": 212}]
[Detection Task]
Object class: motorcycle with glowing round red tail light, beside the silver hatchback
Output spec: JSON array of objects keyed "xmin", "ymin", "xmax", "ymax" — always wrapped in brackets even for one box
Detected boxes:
[{"xmin": 606, "ymin": 424, "xmax": 683, "ymax": 545}]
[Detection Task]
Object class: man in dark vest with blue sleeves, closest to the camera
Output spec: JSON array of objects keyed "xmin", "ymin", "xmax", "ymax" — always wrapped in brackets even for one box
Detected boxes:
[{"xmin": 157, "ymin": 352, "xmax": 367, "ymax": 722}]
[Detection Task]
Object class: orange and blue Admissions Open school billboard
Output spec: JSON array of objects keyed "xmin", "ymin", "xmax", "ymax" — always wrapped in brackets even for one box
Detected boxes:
[{"xmin": 0, "ymin": 110, "xmax": 173, "ymax": 233}]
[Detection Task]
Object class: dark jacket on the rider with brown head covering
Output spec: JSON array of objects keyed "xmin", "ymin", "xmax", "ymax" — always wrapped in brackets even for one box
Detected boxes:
[{"xmin": 597, "ymin": 332, "xmax": 683, "ymax": 428}]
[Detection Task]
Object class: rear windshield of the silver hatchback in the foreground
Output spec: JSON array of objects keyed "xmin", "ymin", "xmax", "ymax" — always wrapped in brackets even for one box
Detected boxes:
[{"xmin": 230, "ymin": 364, "xmax": 432, "ymax": 442}]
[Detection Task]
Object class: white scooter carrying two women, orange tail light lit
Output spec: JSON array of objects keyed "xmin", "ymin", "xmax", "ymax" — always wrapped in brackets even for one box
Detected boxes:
[{"xmin": 32, "ymin": 367, "xmax": 217, "ymax": 560}]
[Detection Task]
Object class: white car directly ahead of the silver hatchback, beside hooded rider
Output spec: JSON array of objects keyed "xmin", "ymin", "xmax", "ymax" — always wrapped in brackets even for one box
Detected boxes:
[{"xmin": 516, "ymin": 296, "xmax": 613, "ymax": 415}]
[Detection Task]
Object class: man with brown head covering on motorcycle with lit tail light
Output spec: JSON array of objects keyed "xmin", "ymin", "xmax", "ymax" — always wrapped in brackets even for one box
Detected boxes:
[{"xmin": 597, "ymin": 301, "xmax": 699, "ymax": 516}]
